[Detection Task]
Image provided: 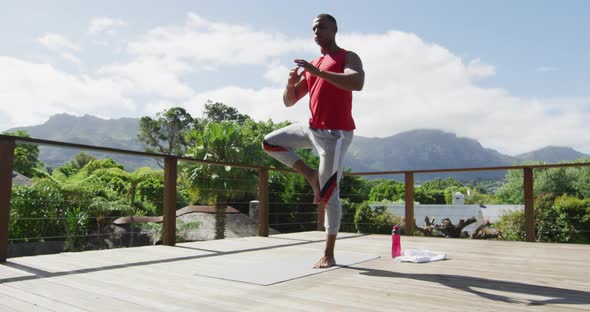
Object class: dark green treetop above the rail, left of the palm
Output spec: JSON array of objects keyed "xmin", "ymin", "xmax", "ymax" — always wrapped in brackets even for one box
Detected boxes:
[{"xmin": 137, "ymin": 107, "xmax": 199, "ymax": 155}]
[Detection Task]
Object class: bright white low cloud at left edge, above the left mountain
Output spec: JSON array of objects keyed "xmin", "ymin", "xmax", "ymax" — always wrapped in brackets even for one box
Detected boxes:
[{"xmin": 0, "ymin": 56, "xmax": 138, "ymax": 129}]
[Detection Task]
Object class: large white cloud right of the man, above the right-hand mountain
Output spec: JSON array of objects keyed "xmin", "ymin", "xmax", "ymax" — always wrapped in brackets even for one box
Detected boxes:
[{"xmin": 342, "ymin": 32, "xmax": 590, "ymax": 154}]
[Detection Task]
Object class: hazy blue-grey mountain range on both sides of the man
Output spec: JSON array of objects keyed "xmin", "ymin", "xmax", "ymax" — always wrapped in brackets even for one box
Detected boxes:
[{"xmin": 8, "ymin": 114, "xmax": 590, "ymax": 181}]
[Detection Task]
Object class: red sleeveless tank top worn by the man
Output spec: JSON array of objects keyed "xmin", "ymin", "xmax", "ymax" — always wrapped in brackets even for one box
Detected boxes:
[{"xmin": 305, "ymin": 49, "xmax": 355, "ymax": 131}]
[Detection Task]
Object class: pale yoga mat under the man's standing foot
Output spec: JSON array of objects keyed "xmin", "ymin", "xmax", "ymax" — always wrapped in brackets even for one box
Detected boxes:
[{"xmin": 195, "ymin": 247, "xmax": 379, "ymax": 286}]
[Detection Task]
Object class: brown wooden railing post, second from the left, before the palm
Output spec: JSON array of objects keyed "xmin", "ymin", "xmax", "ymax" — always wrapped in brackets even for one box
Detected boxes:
[{"xmin": 162, "ymin": 156, "xmax": 178, "ymax": 246}]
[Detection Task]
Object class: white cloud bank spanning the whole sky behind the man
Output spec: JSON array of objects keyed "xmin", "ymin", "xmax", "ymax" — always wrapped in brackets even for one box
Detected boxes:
[{"xmin": 0, "ymin": 14, "xmax": 590, "ymax": 154}]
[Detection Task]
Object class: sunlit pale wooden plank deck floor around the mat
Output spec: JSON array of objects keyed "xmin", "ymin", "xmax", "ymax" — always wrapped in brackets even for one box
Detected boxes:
[{"xmin": 0, "ymin": 232, "xmax": 590, "ymax": 312}]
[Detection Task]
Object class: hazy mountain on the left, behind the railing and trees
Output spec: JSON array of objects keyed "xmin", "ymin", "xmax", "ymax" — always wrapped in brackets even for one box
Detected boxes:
[{"xmin": 8, "ymin": 114, "xmax": 157, "ymax": 170}]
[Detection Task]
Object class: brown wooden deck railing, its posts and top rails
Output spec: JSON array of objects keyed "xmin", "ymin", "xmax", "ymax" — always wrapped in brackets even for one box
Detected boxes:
[{"xmin": 0, "ymin": 135, "xmax": 590, "ymax": 262}]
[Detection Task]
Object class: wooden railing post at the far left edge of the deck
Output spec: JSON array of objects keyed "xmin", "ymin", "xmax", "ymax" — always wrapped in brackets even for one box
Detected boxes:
[{"xmin": 0, "ymin": 138, "xmax": 16, "ymax": 263}]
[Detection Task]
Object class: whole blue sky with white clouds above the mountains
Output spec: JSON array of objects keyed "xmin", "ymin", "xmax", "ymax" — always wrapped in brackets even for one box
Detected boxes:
[{"xmin": 0, "ymin": 0, "xmax": 590, "ymax": 155}]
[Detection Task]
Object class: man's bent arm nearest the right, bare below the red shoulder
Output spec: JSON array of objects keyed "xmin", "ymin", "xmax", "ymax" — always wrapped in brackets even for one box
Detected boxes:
[{"xmin": 295, "ymin": 51, "xmax": 365, "ymax": 91}]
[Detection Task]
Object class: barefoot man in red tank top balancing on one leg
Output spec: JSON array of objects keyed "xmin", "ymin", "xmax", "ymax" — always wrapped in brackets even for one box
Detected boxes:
[{"xmin": 263, "ymin": 14, "xmax": 365, "ymax": 268}]
